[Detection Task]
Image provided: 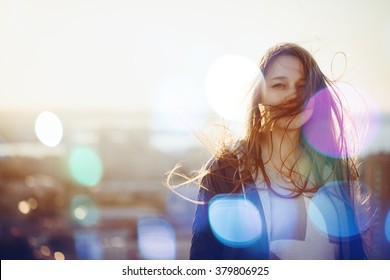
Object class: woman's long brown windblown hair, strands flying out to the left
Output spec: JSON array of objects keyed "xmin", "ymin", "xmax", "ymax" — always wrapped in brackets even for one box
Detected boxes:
[{"xmin": 167, "ymin": 43, "xmax": 358, "ymax": 201}]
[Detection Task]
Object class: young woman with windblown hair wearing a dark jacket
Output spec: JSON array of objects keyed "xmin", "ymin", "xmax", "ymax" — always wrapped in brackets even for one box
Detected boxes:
[{"xmin": 167, "ymin": 43, "xmax": 368, "ymax": 259}]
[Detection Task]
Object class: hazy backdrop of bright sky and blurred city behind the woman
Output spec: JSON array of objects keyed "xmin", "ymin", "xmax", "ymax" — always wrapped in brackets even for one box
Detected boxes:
[{"xmin": 0, "ymin": 0, "xmax": 390, "ymax": 259}]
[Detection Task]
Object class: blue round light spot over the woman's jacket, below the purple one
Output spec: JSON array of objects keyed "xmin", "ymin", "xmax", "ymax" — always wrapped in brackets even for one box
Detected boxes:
[{"xmin": 308, "ymin": 182, "xmax": 360, "ymax": 238}]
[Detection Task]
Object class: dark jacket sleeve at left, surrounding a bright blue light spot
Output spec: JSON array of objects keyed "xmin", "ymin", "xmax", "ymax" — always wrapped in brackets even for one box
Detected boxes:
[{"xmin": 190, "ymin": 156, "xmax": 269, "ymax": 260}]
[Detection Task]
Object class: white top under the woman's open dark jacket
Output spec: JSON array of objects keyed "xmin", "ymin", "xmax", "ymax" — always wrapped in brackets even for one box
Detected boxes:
[{"xmin": 256, "ymin": 168, "xmax": 339, "ymax": 260}]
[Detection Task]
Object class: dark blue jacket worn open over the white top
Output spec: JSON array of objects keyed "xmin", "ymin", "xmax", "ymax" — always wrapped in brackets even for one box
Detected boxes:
[{"xmin": 190, "ymin": 160, "xmax": 366, "ymax": 260}]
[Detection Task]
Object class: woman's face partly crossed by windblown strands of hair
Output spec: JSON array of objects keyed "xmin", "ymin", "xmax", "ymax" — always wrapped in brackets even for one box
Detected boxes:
[{"xmin": 261, "ymin": 55, "xmax": 313, "ymax": 130}]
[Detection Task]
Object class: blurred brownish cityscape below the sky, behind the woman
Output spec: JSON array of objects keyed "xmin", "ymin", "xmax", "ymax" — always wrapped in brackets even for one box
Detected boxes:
[{"xmin": 0, "ymin": 110, "xmax": 390, "ymax": 260}]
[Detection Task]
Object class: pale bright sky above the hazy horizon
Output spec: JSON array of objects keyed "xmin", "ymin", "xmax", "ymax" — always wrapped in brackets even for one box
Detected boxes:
[{"xmin": 0, "ymin": 0, "xmax": 390, "ymax": 112}]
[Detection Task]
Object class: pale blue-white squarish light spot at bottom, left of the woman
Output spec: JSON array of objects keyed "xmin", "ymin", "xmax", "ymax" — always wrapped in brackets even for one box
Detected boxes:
[{"xmin": 137, "ymin": 217, "xmax": 176, "ymax": 260}]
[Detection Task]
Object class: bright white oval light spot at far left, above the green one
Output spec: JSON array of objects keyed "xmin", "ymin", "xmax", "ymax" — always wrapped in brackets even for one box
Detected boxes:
[{"xmin": 35, "ymin": 111, "xmax": 63, "ymax": 147}]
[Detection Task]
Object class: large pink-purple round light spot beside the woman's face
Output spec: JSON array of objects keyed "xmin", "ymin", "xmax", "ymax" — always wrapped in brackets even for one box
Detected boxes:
[{"xmin": 303, "ymin": 85, "xmax": 379, "ymax": 157}]
